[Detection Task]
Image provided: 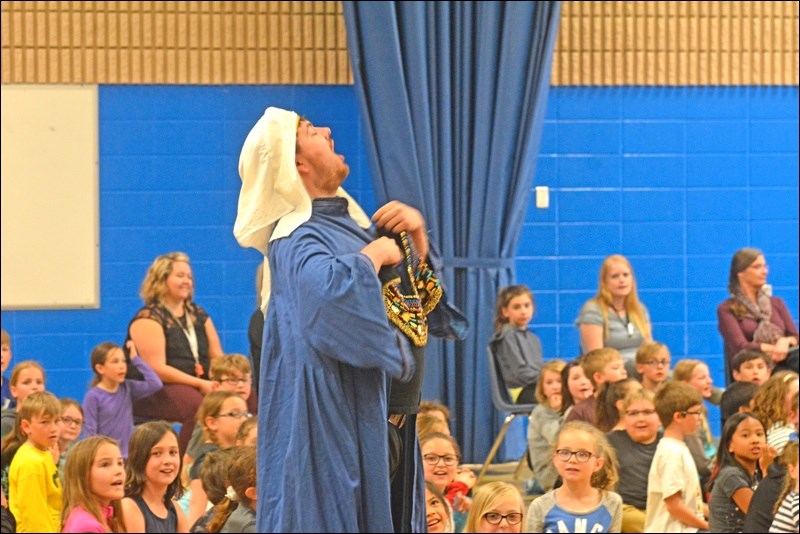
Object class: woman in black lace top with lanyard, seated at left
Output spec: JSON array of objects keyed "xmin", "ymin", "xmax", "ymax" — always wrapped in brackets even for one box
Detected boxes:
[{"xmin": 128, "ymin": 252, "xmax": 223, "ymax": 454}]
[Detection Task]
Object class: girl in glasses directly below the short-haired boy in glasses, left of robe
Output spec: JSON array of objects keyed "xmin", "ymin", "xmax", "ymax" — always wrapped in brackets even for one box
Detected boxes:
[{"xmin": 186, "ymin": 391, "xmax": 252, "ymax": 525}]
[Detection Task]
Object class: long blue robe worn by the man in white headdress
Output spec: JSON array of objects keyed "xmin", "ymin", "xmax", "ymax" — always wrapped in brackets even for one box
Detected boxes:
[{"xmin": 257, "ymin": 198, "xmax": 414, "ymax": 532}]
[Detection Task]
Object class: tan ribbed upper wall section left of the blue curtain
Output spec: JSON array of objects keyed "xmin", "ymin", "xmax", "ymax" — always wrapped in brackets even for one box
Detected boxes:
[{"xmin": 0, "ymin": 1, "xmax": 353, "ymax": 84}]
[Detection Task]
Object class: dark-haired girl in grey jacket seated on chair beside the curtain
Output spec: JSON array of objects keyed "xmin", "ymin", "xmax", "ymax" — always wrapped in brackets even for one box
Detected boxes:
[{"xmin": 489, "ymin": 285, "xmax": 543, "ymax": 404}]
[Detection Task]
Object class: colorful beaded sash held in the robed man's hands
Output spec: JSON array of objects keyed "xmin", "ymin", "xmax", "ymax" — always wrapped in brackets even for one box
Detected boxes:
[{"xmin": 383, "ymin": 232, "xmax": 442, "ymax": 347}]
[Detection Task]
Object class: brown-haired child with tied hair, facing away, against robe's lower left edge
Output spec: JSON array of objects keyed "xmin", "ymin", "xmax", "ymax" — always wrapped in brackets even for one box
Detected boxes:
[{"xmin": 208, "ymin": 447, "xmax": 258, "ymax": 533}]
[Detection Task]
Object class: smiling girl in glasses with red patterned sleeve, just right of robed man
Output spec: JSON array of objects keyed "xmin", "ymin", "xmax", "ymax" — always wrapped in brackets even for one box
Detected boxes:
[{"xmin": 419, "ymin": 432, "xmax": 475, "ymax": 532}]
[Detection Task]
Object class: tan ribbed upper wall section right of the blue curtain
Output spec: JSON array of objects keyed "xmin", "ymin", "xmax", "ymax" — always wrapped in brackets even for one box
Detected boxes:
[{"xmin": 551, "ymin": 1, "xmax": 800, "ymax": 85}]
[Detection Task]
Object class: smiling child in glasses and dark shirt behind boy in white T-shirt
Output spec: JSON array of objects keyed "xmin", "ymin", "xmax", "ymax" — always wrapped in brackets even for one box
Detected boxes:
[{"xmin": 606, "ymin": 389, "xmax": 661, "ymax": 532}]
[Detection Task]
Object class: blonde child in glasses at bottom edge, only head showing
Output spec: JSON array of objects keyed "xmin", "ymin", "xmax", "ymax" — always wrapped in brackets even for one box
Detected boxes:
[{"xmin": 463, "ymin": 482, "xmax": 525, "ymax": 532}]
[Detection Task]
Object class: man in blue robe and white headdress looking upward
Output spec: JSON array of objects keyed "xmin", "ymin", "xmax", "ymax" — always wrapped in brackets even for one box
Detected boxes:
[{"xmin": 234, "ymin": 108, "xmax": 438, "ymax": 532}]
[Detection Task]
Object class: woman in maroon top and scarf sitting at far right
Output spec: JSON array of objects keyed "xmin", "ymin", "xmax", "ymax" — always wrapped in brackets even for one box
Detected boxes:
[{"xmin": 717, "ymin": 248, "xmax": 798, "ymax": 382}]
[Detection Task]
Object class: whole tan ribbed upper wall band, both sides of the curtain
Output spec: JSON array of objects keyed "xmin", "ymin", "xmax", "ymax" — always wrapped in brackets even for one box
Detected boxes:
[{"xmin": 0, "ymin": 1, "xmax": 800, "ymax": 85}]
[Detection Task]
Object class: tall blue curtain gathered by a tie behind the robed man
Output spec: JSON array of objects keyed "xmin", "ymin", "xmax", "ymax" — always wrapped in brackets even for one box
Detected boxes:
[{"xmin": 343, "ymin": 1, "xmax": 560, "ymax": 463}]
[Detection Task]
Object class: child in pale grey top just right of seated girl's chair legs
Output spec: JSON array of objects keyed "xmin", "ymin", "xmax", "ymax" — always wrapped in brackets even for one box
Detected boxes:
[{"xmin": 528, "ymin": 360, "xmax": 567, "ymax": 493}]
